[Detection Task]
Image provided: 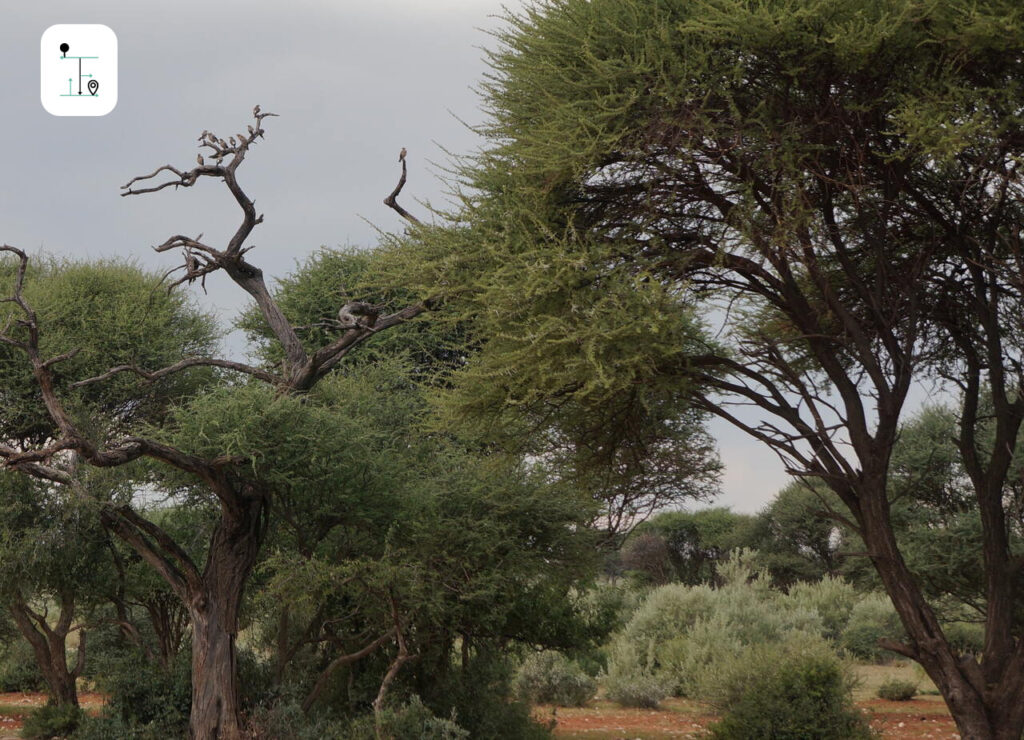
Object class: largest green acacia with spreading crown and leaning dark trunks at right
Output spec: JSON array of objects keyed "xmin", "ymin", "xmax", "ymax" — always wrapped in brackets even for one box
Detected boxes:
[{"xmin": 380, "ymin": 0, "xmax": 1024, "ymax": 738}]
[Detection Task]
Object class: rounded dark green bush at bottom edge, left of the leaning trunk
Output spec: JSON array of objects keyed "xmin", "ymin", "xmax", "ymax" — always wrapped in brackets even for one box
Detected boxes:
[{"xmin": 710, "ymin": 641, "xmax": 873, "ymax": 740}]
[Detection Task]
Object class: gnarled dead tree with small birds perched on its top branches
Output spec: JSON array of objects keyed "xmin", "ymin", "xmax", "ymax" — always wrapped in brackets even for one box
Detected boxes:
[{"xmin": 0, "ymin": 105, "xmax": 427, "ymax": 740}]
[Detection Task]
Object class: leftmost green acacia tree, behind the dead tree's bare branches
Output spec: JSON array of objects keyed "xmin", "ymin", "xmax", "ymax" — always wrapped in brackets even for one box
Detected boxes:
[{"xmin": 0, "ymin": 257, "xmax": 216, "ymax": 704}]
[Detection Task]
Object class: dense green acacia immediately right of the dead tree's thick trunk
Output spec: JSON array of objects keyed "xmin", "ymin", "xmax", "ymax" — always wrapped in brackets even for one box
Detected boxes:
[{"xmin": 235, "ymin": 250, "xmax": 596, "ymax": 737}]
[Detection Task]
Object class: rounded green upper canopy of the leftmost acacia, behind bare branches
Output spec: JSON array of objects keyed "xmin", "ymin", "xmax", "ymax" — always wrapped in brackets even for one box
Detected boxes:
[{"xmin": 0, "ymin": 257, "xmax": 217, "ymax": 443}]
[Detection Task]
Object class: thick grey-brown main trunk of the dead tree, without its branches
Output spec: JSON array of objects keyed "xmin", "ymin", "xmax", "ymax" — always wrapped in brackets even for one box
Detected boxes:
[{"xmin": 188, "ymin": 497, "xmax": 265, "ymax": 740}]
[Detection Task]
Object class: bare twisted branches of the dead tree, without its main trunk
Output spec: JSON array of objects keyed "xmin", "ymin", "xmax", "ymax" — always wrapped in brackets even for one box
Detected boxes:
[{"xmin": 0, "ymin": 111, "xmax": 427, "ymax": 599}]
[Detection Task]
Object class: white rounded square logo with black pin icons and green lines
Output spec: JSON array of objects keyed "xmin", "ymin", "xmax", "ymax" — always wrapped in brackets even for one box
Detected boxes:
[{"xmin": 39, "ymin": 24, "xmax": 118, "ymax": 116}]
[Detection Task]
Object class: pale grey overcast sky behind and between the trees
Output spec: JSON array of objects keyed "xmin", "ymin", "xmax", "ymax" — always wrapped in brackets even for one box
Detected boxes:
[{"xmin": 0, "ymin": 0, "xmax": 785, "ymax": 512}]
